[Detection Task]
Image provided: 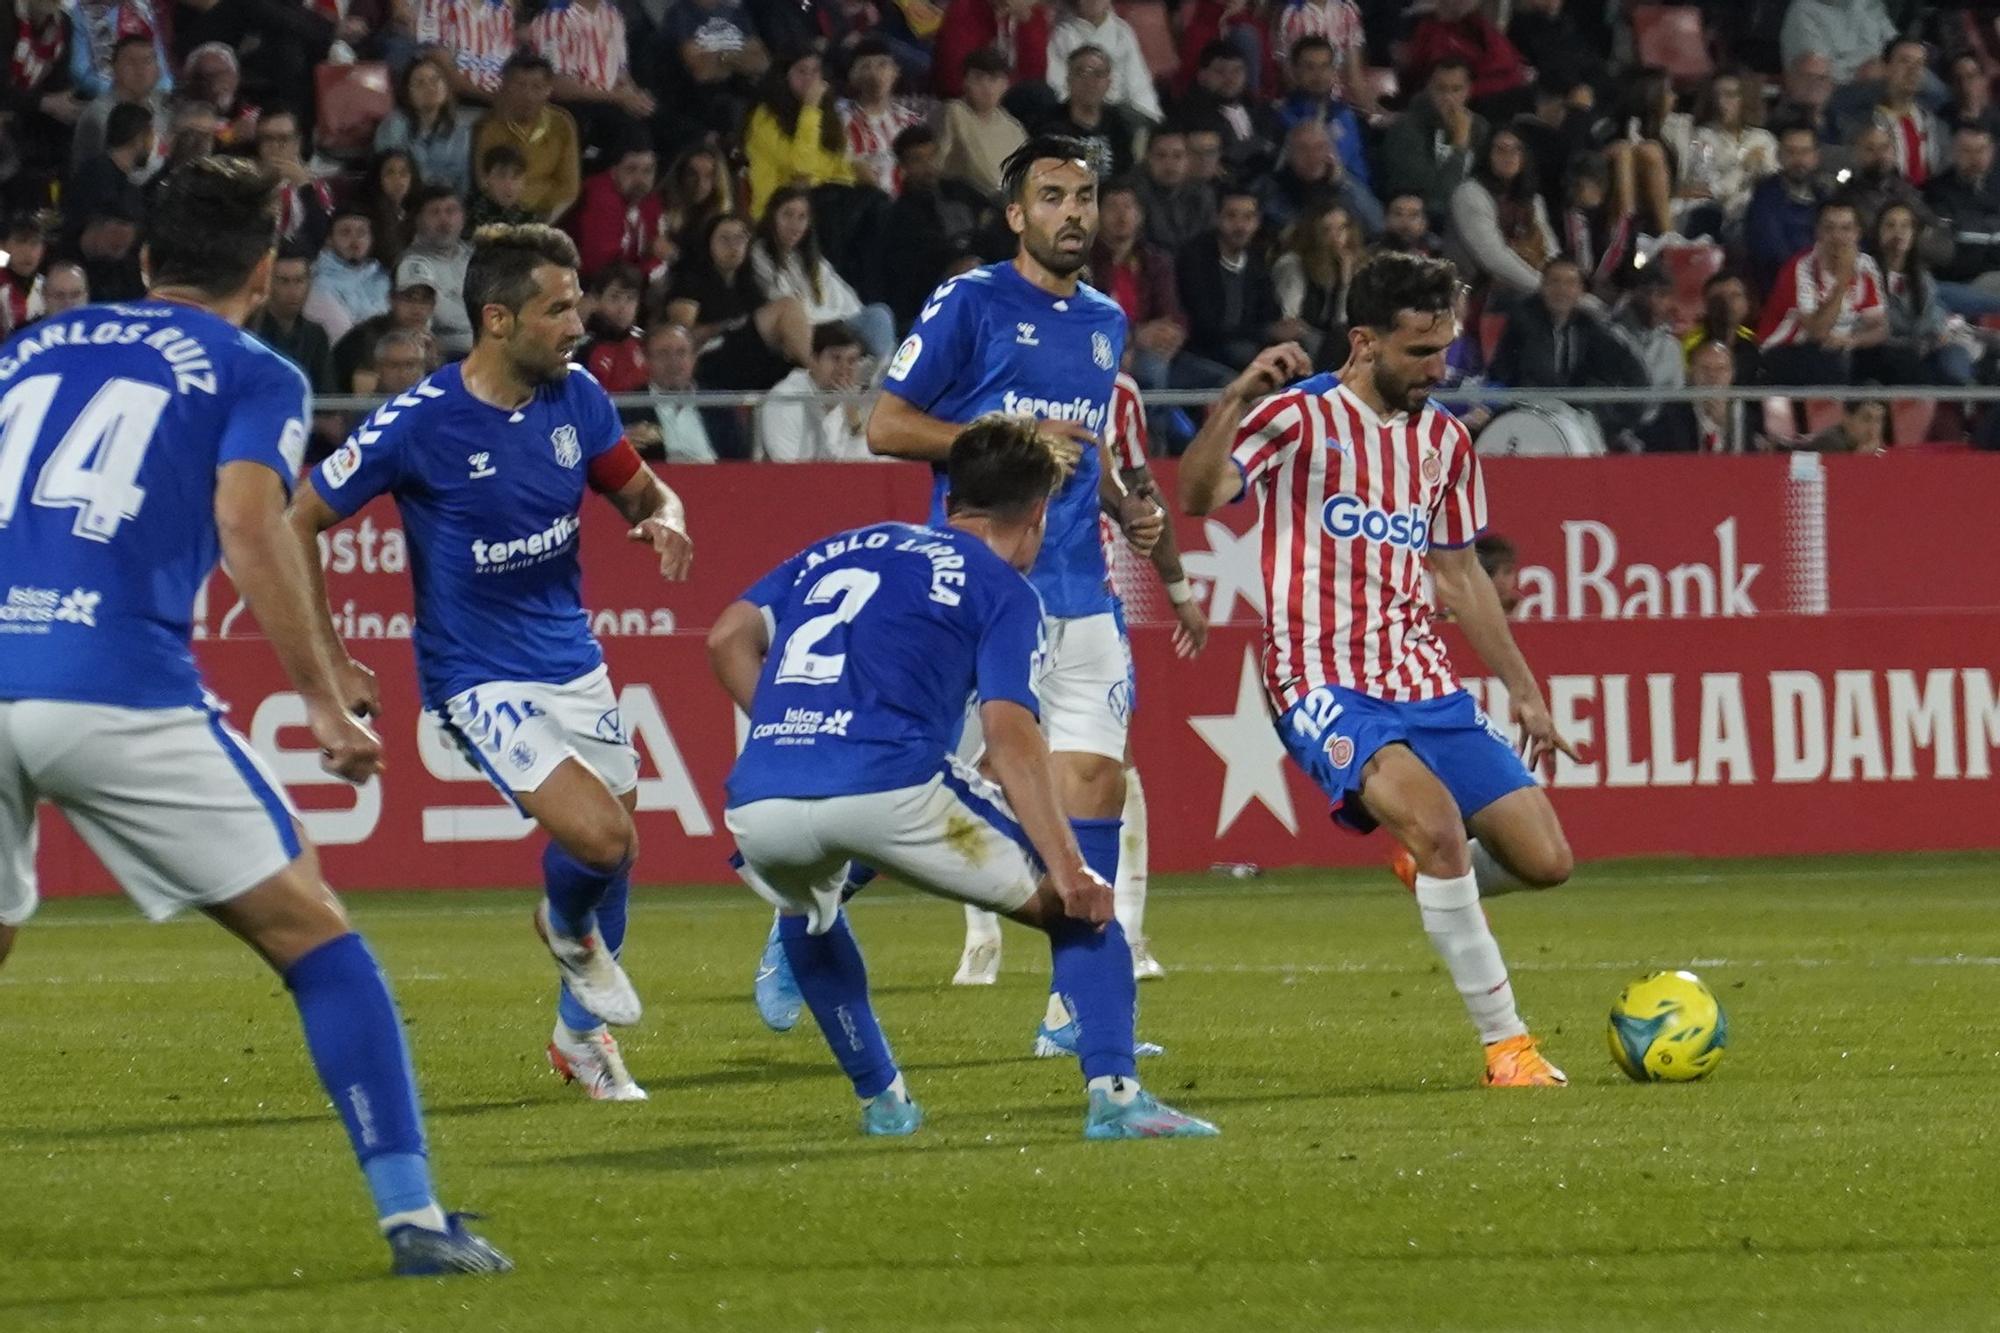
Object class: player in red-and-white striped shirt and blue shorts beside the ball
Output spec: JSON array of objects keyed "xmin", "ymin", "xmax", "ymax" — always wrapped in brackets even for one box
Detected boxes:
[{"xmin": 1180, "ymin": 254, "xmax": 1576, "ymax": 1087}]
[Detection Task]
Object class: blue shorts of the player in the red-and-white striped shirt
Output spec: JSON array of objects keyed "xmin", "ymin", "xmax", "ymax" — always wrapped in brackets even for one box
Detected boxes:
[{"xmin": 1278, "ymin": 685, "xmax": 1534, "ymax": 833}]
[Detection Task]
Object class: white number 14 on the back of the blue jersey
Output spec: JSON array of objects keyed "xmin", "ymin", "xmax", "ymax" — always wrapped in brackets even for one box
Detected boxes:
[{"xmin": 0, "ymin": 374, "xmax": 174, "ymax": 542}]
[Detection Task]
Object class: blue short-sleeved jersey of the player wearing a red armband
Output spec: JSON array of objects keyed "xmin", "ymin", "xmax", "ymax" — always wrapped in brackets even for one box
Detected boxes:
[{"xmin": 312, "ymin": 352, "xmax": 624, "ymax": 709}]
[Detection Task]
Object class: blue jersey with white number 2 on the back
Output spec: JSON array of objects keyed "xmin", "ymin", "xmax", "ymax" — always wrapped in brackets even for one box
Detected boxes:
[{"xmin": 728, "ymin": 522, "xmax": 1044, "ymax": 805}]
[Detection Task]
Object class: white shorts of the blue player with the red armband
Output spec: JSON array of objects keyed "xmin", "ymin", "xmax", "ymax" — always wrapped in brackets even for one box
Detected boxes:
[{"xmin": 432, "ymin": 667, "xmax": 638, "ymax": 807}]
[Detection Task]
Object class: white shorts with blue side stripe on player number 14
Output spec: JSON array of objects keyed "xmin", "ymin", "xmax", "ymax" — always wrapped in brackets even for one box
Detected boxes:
[{"xmin": 0, "ymin": 699, "xmax": 302, "ymax": 925}]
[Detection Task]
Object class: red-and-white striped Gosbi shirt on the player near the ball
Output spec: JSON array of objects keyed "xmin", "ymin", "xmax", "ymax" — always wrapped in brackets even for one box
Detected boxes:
[{"xmin": 1234, "ymin": 386, "xmax": 1486, "ymax": 711}]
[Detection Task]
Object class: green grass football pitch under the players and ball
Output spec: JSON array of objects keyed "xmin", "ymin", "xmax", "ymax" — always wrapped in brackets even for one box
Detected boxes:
[{"xmin": 0, "ymin": 857, "xmax": 2000, "ymax": 1333}]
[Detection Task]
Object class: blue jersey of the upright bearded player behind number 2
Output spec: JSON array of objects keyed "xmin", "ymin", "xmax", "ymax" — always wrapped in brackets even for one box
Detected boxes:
[{"xmin": 882, "ymin": 264, "xmax": 1126, "ymax": 618}]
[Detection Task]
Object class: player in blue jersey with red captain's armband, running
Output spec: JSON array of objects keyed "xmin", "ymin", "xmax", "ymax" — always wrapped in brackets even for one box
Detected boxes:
[{"xmin": 292, "ymin": 224, "xmax": 694, "ymax": 1101}]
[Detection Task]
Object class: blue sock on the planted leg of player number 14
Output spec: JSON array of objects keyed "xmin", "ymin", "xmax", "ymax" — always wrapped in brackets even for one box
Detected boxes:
[{"xmin": 284, "ymin": 933, "xmax": 436, "ymax": 1217}]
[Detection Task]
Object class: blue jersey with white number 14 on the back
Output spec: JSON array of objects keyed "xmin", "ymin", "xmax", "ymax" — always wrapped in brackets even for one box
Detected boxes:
[{"xmin": 0, "ymin": 300, "xmax": 310, "ymax": 709}]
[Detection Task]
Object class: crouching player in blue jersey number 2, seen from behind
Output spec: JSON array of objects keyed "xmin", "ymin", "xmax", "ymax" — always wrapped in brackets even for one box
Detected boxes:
[{"xmin": 708, "ymin": 416, "xmax": 1216, "ymax": 1139}]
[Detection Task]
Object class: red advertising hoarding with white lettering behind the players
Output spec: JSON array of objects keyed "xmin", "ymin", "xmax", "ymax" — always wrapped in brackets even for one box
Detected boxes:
[{"xmin": 40, "ymin": 456, "xmax": 2000, "ymax": 895}]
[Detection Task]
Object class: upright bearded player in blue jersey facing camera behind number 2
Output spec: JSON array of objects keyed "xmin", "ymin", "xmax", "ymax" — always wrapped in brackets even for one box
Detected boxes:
[{"xmin": 758, "ymin": 136, "xmax": 1164, "ymax": 1049}]
